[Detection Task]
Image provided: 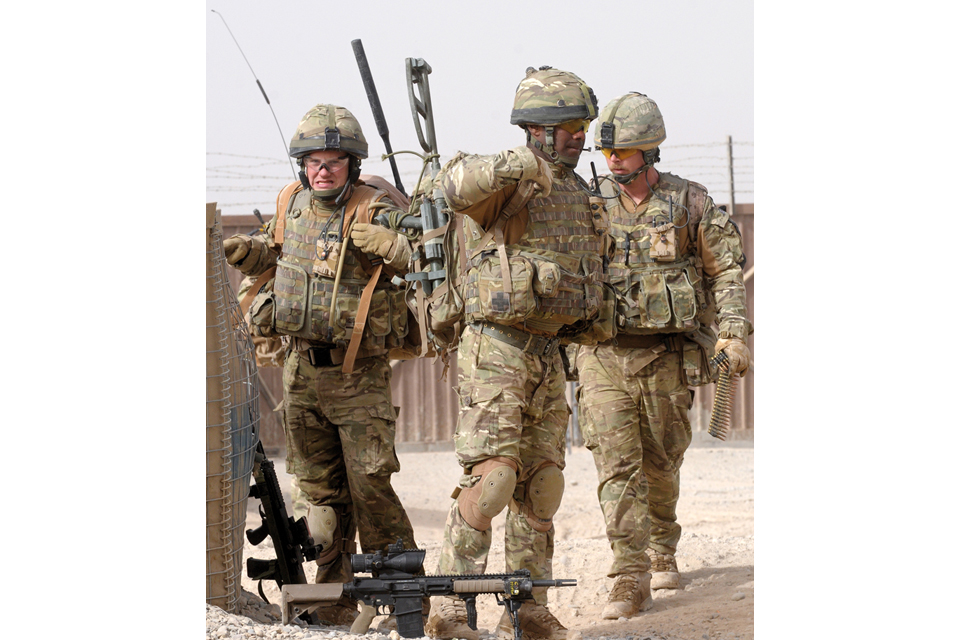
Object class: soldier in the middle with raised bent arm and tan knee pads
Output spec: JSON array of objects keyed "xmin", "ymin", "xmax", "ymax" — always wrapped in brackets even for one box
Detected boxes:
[{"xmin": 426, "ymin": 67, "xmax": 603, "ymax": 640}]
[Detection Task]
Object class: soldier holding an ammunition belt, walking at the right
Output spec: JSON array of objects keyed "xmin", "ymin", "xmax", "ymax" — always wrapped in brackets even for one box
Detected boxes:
[{"xmin": 570, "ymin": 93, "xmax": 753, "ymax": 619}]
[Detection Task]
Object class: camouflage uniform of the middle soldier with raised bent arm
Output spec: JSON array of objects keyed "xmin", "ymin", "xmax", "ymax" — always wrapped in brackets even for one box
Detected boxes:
[{"xmin": 438, "ymin": 107, "xmax": 603, "ymax": 604}]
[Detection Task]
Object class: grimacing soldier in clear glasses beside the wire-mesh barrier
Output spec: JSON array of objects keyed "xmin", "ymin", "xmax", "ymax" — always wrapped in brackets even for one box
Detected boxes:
[{"xmin": 224, "ymin": 104, "xmax": 424, "ymax": 625}]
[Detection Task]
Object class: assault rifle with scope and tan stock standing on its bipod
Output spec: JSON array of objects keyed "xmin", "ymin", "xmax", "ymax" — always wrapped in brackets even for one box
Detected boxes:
[{"xmin": 280, "ymin": 540, "xmax": 577, "ymax": 640}]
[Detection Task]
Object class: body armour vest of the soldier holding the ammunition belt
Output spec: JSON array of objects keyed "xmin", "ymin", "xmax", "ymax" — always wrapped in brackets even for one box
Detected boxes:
[{"xmin": 601, "ymin": 173, "xmax": 715, "ymax": 334}]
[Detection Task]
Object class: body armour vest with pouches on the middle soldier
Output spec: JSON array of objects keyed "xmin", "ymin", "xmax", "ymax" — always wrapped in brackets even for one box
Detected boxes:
[{"xmin": 463, "ymin": 171, "xmax": 603, "ymax": 335}]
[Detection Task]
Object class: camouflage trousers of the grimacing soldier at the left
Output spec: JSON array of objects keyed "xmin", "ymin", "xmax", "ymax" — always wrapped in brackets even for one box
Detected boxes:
[{"xmin": 283, "ymin": 350, "xmax": 416, "ymax": 582}]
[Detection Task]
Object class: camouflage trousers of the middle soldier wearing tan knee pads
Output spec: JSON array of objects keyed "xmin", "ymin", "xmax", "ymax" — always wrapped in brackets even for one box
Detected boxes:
[{"xmin": 437, "ymin": 326, "xmax": 570, "ymax": 605}]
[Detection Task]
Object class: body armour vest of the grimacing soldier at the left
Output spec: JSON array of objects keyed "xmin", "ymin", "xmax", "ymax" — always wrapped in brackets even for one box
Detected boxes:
[{"xmin": 274, "ymin": 185, "xmax": 407, "ymax": 355}]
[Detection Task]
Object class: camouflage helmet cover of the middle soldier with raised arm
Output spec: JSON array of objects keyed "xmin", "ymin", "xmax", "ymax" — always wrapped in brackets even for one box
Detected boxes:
[{"xmin": 510, "ymin": 67, "xmax": 597, "ymax": 126}]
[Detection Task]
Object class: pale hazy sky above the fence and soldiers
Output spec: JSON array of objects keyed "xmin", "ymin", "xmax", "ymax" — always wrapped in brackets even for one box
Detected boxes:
[{"xmin": 206, "ymin": 0, "xmax": 754, "ymax": 214}]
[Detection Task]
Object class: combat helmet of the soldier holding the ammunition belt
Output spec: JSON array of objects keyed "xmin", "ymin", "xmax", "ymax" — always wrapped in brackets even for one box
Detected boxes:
[{"xmin": 593, "ymin": 91, "xmax": 667, "ymax": 184}]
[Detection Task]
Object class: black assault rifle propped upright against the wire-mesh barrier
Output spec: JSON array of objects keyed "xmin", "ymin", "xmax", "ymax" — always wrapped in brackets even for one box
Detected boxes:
[{"xmin": 246, "ymin": 442, "xmax": 323, "ymax": 624}]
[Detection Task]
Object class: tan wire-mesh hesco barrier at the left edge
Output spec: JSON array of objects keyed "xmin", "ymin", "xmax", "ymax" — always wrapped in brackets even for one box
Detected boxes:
[{"xmin": 206, "ymin": 203, "xmax": 260, "ymax": 613}]
